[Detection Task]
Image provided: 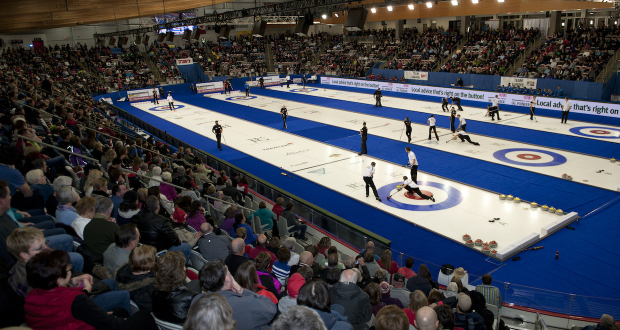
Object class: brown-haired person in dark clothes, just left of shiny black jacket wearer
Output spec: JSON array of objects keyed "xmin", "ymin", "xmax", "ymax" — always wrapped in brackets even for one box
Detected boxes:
[{"xmin": 115, "ymin": 245, "xmax": 157, "ymax": 312}]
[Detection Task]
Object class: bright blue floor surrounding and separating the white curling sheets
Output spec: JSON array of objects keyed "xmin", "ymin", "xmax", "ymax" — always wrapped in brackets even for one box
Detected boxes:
[{"xmin": 111, "ymin": 93, "xmax": 620, "ymax": 317}]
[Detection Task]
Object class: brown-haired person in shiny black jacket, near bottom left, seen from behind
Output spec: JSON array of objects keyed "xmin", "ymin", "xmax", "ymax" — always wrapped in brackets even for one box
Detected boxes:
[{"xmin": 151, "ymin": 251, "xmax": 196, "ymax": 324}]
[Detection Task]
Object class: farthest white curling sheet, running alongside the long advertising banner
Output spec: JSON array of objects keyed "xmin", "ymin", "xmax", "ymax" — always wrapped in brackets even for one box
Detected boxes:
[{"xmin": 269, "ymin": 85, "xmax": 620, "ymax": 143}]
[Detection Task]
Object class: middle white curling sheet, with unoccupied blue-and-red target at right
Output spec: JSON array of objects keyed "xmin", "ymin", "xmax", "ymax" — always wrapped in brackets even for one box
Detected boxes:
[{"xmin": 212, "ymin": 92, "xmax": 620, "ymax": 193}]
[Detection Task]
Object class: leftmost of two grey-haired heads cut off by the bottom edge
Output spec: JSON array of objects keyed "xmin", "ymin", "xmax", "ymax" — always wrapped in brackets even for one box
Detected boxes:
[{"xmin": 183, "ymin": 293, "xmax": 238, "ymax": 330}]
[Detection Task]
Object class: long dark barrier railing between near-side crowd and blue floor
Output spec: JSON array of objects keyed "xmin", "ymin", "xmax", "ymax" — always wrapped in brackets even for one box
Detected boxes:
[{"xmin": 104, "ymin": 102, "xmax": 392, "ymax": 254}]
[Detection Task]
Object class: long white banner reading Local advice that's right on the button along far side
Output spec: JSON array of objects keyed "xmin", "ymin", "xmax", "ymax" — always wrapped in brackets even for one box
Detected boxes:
[{"xmin": 321, "ymin": 77, "xmax": 620, "ymax": 118}]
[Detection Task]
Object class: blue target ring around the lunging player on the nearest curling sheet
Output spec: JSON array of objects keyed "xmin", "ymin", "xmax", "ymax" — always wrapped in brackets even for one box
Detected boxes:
[{"xmin": 377, "ymin": 181, "xmax": 463, "ymax": 211}]
